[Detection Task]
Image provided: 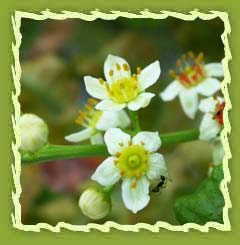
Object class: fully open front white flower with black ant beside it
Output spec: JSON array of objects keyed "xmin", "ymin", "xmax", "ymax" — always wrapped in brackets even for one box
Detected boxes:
[{"xmin": 92, "ymin": 128, "xmax": 168, "ymax": 213}]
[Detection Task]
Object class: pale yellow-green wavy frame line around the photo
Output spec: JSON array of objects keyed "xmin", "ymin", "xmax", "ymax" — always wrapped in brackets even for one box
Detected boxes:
[{"xmin": 12, "ymin": 10, "xmax": 231, "ymax": 232}]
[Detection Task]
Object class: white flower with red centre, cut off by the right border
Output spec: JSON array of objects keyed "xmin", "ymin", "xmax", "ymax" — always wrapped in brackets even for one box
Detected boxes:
[{"xmin": 199, "ymin": 97, "xmax": 225, "ymax": 140}]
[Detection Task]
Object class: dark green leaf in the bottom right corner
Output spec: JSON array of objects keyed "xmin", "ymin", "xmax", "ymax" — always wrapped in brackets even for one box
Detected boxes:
[{"xmin": 174, "ymin": 165, "xmax": 224, "ymax": 225}]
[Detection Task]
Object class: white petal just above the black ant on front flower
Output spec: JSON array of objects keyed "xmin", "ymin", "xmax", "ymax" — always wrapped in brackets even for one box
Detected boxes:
[{"xmin": 147, "ymin": 153, "xmax": 168, "ymax": 179}]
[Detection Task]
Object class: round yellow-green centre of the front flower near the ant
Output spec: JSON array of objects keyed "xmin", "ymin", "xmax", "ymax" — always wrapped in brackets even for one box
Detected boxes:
[{"xmin": 115, "ymin": 145, "xmax": 149, "ymax": 178}]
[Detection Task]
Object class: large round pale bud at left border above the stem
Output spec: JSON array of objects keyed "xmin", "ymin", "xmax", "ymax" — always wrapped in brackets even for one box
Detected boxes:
[{"xmin": 19, "ymin": 114, "xmax": 48, "ymax": 153}]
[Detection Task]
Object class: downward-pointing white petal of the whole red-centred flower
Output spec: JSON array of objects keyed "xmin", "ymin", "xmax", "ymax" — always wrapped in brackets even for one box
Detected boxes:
[{"xmin": 179, "ymin": 88, "xmax": 198, "ymax": 119}]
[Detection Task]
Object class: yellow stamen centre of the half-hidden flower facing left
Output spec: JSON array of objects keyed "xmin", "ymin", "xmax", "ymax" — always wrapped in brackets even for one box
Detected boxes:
[{"xmin": 76, "ymin": 98, "xmax": 102, "ymax": 128}]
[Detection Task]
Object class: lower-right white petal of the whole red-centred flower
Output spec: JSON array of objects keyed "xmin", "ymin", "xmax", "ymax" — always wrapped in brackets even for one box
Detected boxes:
[{"xmin": 196, "ymin": 78, "xmax": 221, "ymax": 96}]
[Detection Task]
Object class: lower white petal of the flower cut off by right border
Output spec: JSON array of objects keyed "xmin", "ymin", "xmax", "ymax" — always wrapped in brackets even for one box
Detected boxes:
[{"xmin": 199, "ymin": 113, "xmax": 221, "ymax": 140}]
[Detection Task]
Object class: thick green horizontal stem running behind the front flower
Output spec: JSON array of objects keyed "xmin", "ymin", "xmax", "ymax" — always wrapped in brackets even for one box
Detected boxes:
[{"xmin": 21, "ymin": 129, "xmax": 199, "ymax": 165}]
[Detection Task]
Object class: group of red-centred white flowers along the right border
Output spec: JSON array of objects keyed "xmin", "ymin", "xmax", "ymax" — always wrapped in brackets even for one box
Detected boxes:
[{"xmin": 160, "ymin": 52, "xmax": 225, "ymax": 165}]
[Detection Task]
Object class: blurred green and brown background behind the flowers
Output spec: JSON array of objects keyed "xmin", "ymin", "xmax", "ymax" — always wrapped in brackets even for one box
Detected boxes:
[{"xmin": 19, "ymin": 17, "xmax": 224, "ymax": 225}]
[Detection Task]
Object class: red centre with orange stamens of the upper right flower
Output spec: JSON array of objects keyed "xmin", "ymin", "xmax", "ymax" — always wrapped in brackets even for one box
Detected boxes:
[{"xmin": 169, "ymin": 52, "xmax": 206, "ymax": 88}]
